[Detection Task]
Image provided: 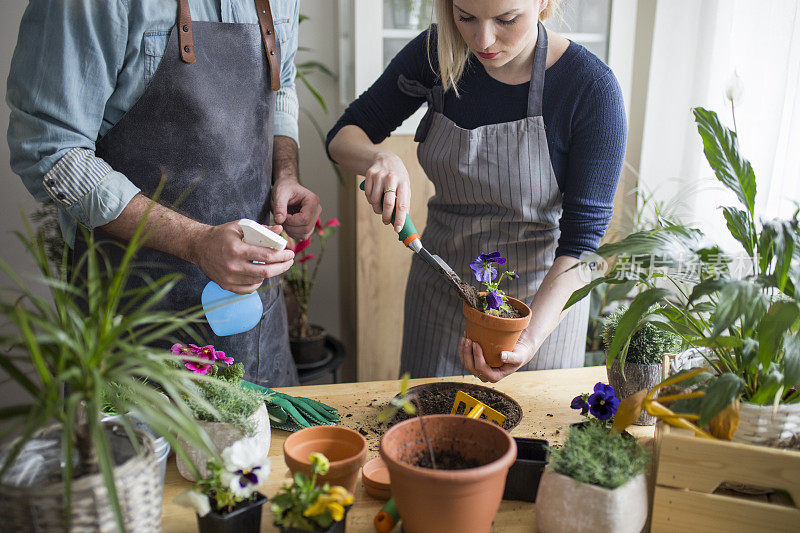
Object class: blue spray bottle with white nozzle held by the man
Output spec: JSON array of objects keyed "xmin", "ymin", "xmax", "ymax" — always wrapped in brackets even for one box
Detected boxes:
[{"xmin": 200, "ymin": 219, "xmax": 286, "ymax": 337}]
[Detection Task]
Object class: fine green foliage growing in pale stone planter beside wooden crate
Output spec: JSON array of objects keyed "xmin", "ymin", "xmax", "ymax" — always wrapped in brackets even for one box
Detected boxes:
[{"xmin": 550, "ymin": 423, "xmax": 650, "ymax": 489}]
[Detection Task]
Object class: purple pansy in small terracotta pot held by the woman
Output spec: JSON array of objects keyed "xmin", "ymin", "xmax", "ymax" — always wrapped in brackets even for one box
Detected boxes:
[{"xmin": 461, "ymin": 252, "xmax": 531, "ymax": 368}]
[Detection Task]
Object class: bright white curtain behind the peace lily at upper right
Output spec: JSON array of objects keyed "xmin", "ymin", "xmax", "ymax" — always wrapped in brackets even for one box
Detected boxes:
[{"xmin": 638, "ymin": 0, "xmax": 800, "ymax": 251}]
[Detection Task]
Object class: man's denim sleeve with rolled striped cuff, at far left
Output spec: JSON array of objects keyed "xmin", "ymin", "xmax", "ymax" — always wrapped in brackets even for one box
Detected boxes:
[{"xmin": 6, "ymin": 0, "xmax": 139, "ymax": 245}]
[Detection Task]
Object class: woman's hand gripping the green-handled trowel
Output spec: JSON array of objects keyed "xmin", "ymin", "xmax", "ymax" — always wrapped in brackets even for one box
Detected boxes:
[{"xmin": 364, "ymin": 151, "xmax": 411, "ymax": 233}]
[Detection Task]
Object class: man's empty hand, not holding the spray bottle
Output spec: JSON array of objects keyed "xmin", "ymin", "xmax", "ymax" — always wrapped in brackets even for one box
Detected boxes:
[{"xmin": 272, "ymin": 177, "xmax": 322, "ymax": 241}]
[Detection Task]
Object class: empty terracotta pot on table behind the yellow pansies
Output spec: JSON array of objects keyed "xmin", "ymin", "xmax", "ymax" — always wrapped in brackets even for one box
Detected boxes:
[{"xmin": 283, "ymin": 426, "xmax": 367, "ymax": 493}]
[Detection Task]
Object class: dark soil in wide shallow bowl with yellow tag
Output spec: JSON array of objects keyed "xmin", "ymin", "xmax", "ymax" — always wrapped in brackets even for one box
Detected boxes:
[{"xmin": 389, "ymin": 381, "xmax": 522, "ymax": 430}]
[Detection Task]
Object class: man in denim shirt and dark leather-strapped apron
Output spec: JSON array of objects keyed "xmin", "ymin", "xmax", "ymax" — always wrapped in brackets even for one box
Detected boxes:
[{"xmin": 7, "ymin": 0, "xmax": 320, "ymax": 387}]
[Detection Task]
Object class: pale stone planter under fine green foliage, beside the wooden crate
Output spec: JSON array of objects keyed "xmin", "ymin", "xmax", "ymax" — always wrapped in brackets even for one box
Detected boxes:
[{"xmin": 536, "ymin": 469, "xmax": 647, "ymax": 533}]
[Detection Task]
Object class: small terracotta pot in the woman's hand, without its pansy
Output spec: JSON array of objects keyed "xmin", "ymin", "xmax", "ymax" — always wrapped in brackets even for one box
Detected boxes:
[{"xmin": 461, "ymin": 293, "xmax": 531, "ymax": 368}]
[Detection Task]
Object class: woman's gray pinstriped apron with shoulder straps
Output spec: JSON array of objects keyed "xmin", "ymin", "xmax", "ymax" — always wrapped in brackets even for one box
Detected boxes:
[{"xmin": 399, "ymin": 23, "xmax": 589, "ymax": 377}]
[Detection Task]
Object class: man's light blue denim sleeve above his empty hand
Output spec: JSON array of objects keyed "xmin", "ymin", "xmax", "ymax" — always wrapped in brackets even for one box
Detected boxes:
[{"xmin": 274, "ymin": 1, "xmax": 300, "ymax": 146}]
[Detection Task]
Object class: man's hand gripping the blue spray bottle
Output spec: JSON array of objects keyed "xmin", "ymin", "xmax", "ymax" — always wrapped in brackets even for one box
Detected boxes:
[{"xmin": 190, "ymin": 221, "xmax": 294, "ymax": 294}]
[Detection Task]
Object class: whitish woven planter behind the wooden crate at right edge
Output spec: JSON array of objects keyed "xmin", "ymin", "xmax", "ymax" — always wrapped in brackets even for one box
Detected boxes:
[{"xmin": 733, "ymin": 402, "xmax": 800, "ymax": 444}]
